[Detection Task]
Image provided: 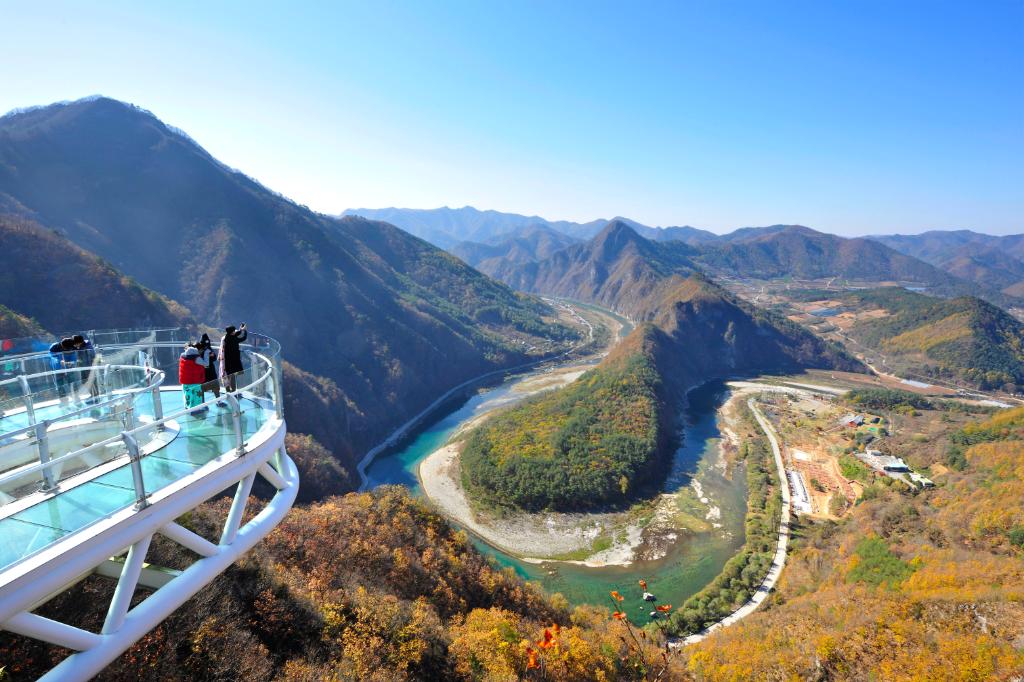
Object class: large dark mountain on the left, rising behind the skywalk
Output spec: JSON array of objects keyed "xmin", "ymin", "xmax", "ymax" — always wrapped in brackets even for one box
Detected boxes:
[{"xmin": 0, "ymin": 98, "xmax": 567, "ymax": 470}]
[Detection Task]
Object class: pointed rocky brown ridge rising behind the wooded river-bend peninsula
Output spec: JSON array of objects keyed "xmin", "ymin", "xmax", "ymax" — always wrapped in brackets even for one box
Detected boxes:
[{"xmin": 514, "ymin": 220, "xmax": 858, "ymax": 382}]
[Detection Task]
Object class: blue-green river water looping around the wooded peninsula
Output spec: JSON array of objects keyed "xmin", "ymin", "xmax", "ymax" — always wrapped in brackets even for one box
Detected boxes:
[{"xmin": 367, "ymin": 375, "xmax": 746, "ymax": 623}]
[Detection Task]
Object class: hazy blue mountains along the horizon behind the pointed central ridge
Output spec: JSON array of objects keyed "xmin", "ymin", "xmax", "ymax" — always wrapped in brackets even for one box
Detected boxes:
[{"xmin": 346, "ymin": 207, "xmax": 1024, "ymax": 306}]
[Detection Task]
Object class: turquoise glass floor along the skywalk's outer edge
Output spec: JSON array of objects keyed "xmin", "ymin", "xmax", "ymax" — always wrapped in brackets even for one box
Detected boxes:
[{"xmin": 0, "ymin": 390, "xmax": 273, "ymax": 570}]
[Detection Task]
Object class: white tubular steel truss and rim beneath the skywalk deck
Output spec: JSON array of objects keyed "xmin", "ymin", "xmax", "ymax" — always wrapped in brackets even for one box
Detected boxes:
[{"xmin": 0, "ymin": 420, "xmax": 299, "ymax": 682}]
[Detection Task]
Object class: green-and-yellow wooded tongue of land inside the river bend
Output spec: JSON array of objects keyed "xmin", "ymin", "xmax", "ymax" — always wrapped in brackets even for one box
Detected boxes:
[{"xmin": 461, "ymin": 329, "xmax": 672, "ymax": 511}]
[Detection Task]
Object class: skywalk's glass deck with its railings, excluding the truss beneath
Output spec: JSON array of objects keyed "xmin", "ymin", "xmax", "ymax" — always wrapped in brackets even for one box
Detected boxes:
[{"xmin": 0, "ymin": 330, "xmax": 280, "ymax": 573}]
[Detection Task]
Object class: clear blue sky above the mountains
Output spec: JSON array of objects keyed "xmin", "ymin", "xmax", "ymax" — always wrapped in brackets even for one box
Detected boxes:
[{"xmin": 0, "ymin": 0, "xmax": 1024, "ymax": 235}]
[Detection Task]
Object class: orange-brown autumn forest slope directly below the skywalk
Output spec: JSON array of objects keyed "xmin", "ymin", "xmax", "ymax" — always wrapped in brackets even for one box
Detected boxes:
[{"xmin": 0, "ymin": 487, "xmax": 684, "ymax": 682}]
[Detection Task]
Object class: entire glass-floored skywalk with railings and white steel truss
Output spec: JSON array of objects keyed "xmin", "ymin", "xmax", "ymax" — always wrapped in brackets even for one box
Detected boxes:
[{"xmin": 0, "ymin": 329, "xmax": 299, "ymax": 682}]
